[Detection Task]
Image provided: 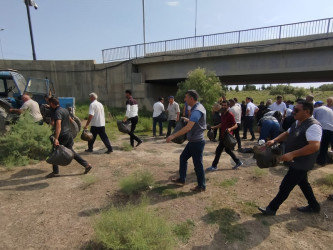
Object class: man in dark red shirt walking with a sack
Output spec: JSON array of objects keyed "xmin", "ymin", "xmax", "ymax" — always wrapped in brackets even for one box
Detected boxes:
[{"xmin": 206, "ymin": 101, "xmax": 243, "ymax": 171}]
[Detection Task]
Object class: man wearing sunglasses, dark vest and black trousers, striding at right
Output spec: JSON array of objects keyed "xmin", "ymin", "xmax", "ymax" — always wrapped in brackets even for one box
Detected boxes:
[{"xmin": 258, "ymin": 101, "xmax": 322, "ymax": 215}]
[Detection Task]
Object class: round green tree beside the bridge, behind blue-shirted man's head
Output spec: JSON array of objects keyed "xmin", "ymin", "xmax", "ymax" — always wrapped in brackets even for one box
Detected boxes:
[{"xmin": 176, "ymin": 68, "xmax": 222, "ymax": 108}]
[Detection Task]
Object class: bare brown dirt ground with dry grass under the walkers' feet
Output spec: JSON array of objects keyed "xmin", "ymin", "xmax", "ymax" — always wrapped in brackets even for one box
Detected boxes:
[{"xmin": 0, "ymin": 132, "xmax": 333, "ymax": 249}]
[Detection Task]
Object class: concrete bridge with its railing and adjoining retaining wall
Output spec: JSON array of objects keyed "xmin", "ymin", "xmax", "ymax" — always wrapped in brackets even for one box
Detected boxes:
[{"xmin": 0, "ymin": 16, "xmax": 333, "ymax": 109}]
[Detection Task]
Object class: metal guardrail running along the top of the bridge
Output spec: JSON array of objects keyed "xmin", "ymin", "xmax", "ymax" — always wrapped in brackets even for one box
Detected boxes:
[{"xmin": 102, "ymin": 18, "xmax": 333, "ymax": 63}]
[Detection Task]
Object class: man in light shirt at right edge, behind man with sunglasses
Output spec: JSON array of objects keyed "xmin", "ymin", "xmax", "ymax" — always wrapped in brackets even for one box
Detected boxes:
[{"xmin": 313, "ymin": 101, "xmax": 333, "ymax": 166}]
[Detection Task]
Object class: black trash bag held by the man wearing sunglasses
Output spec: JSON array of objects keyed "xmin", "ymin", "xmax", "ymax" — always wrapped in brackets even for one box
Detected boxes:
[{"xmin": 253, "ymin": 144, "xmax": 282, "ymax": 168}]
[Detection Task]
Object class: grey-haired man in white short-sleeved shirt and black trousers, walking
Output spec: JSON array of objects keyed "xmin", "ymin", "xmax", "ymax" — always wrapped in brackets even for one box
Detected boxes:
[{"xmin": 84, "ymin": 92, "xmax": 113, "ymax": 154}]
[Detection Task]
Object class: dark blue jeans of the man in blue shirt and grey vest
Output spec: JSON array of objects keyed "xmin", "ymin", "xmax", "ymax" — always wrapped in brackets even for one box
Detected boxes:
[{"xmin": 179, "ymin": 141, "xmax": 206, "ymax": 187}]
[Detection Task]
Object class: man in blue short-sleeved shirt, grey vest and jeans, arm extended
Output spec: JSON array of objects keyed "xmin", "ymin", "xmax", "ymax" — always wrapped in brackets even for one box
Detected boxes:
[{"xmin": 166, "ymin": 90, "xmax": 206, "ymax": 192}]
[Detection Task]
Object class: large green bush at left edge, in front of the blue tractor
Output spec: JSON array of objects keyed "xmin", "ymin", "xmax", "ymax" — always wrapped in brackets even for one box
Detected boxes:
[{"xmin": 0, "ymin": 113, "xmax": 52, "ymax": 167}]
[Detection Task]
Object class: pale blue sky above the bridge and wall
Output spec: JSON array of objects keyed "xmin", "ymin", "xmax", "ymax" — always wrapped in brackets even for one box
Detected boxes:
[{"xmin": 0, "ymin": 0, "xmax": 333, "ymax": 88}]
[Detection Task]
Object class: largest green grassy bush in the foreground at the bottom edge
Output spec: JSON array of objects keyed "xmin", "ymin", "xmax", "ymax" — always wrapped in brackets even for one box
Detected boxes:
[{"xmin": 94, "ymin": 204, "xmax": 175, "ymax": 250}]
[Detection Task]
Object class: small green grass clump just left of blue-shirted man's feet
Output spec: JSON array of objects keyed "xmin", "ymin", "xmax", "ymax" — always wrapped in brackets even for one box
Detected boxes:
[{"xmin": 119, "ymin": 171, "xmax": 154, "ymax": 195}]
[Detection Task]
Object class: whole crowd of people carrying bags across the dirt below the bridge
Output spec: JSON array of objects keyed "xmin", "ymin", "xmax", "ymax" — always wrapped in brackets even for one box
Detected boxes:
[{"xmin": 15, "ymin": 87, "xmax": 333, "ymax": 215}]
